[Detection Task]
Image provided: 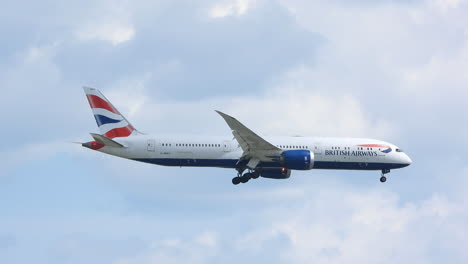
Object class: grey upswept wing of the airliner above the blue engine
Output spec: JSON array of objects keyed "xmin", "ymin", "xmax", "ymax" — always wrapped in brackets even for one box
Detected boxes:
[{"xmin": 216, "ymin": 111, "xmax": 281, "ymax": 169}]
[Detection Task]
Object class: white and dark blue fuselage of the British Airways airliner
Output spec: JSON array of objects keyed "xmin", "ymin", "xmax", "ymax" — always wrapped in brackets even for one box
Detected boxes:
[{"xmin": 97, "ymin": 135, "xmax": 411, "ymax": 170}]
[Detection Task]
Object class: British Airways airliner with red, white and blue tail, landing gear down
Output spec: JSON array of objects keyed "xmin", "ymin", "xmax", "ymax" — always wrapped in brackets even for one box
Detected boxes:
[{"xmin": 82, "ymin": 87, "xmax": 412, "ymax": 185}]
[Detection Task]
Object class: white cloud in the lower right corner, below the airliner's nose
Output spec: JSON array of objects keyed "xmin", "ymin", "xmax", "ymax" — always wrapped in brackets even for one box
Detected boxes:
[{"xmin": 236, "ymin": 184, "xmax": 468, "ymax": 263}]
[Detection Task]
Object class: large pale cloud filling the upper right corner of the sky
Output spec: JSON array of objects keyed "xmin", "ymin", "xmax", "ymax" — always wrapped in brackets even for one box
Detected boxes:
[{"xmin": 281, "ymin": 0, "xmax": 468, "ymax": 152}]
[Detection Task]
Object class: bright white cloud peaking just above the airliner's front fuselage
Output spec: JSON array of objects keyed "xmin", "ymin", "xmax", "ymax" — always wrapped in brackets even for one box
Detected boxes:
[{"xmin": 223, "ymin": 68, "xmax": 397, "ymax": 138}]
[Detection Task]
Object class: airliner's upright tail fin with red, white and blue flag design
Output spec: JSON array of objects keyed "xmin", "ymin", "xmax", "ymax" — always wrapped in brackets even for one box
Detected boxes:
[{"xmin": 83, "ymin": 87, "xmax": 138, "ymax": 138}]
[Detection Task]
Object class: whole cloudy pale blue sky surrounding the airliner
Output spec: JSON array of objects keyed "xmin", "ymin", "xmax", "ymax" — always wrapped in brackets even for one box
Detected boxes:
[{"xmin": 0, "ymin": 0, "xmax": 468, "ymax": 264}]
